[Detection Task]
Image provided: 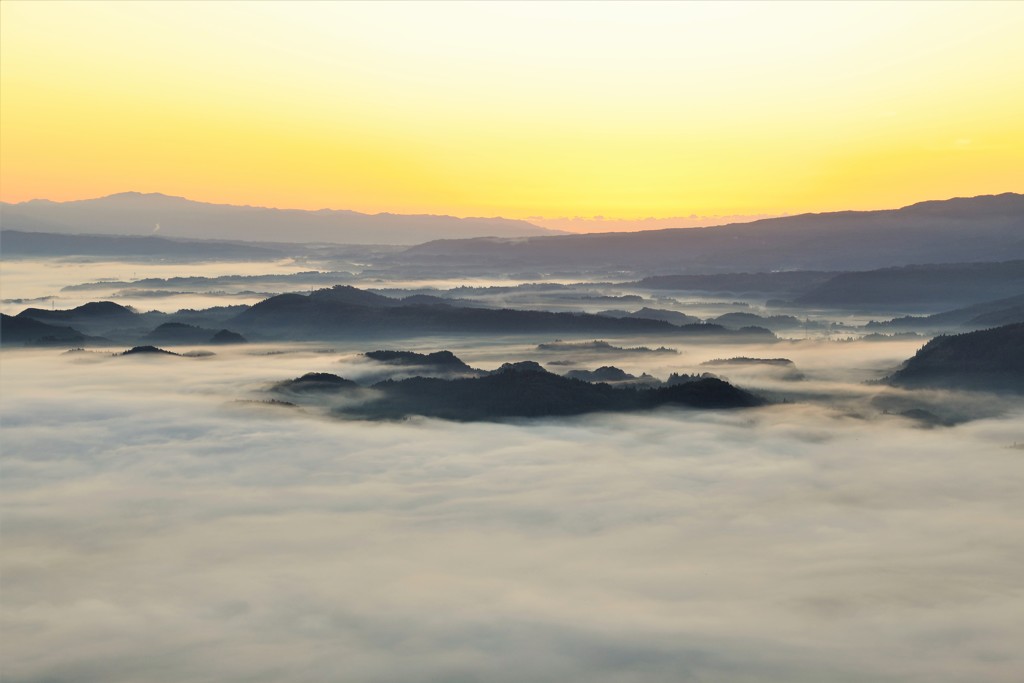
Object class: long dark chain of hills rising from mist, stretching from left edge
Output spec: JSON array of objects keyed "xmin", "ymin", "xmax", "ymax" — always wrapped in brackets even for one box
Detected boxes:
[{"xmin": 0, "ymin": 285, "xmax": 776, "ymax": 345}]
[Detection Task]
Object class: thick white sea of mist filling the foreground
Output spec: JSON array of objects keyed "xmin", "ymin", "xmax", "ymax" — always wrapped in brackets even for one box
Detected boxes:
[{"xmin": 0, "ymin": 350, "xmax": 1024, "ymax": 683}]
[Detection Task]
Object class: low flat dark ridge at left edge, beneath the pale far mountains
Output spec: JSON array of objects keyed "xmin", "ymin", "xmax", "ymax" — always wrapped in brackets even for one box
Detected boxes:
[{"xmin": 0, "ymin": 231, "xmax": 285, "ymax": 261}]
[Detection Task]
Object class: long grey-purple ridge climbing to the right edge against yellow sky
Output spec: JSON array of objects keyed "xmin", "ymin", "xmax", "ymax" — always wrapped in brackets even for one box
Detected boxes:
[{"xmin": 406, "ymin": 193, "xmax": 1024, "ymax": 274}]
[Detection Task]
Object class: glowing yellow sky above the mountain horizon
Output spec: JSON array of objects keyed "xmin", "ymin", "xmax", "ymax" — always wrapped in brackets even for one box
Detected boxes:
[{"xmin": 0, "ymin": 0, "xmax": 1024, "ymax": 218}]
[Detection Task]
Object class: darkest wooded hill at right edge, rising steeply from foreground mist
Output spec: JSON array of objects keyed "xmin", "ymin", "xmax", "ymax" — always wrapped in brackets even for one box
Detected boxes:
[{"xmin": 887, "ymin": 323, "xmax": 1024, "ymax": 393}]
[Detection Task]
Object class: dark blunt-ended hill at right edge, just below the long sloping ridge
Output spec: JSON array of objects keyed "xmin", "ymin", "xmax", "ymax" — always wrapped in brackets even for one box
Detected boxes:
[{"xmin": 796, "ymin": 260, "xmax": 1024, "ymax": 308}]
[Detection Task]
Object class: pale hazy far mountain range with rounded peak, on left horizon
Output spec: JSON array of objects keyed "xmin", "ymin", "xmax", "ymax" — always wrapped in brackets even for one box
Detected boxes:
[{"xmin": 0, "ymin": 193, "xmax": 558, "ymax": 245}]
